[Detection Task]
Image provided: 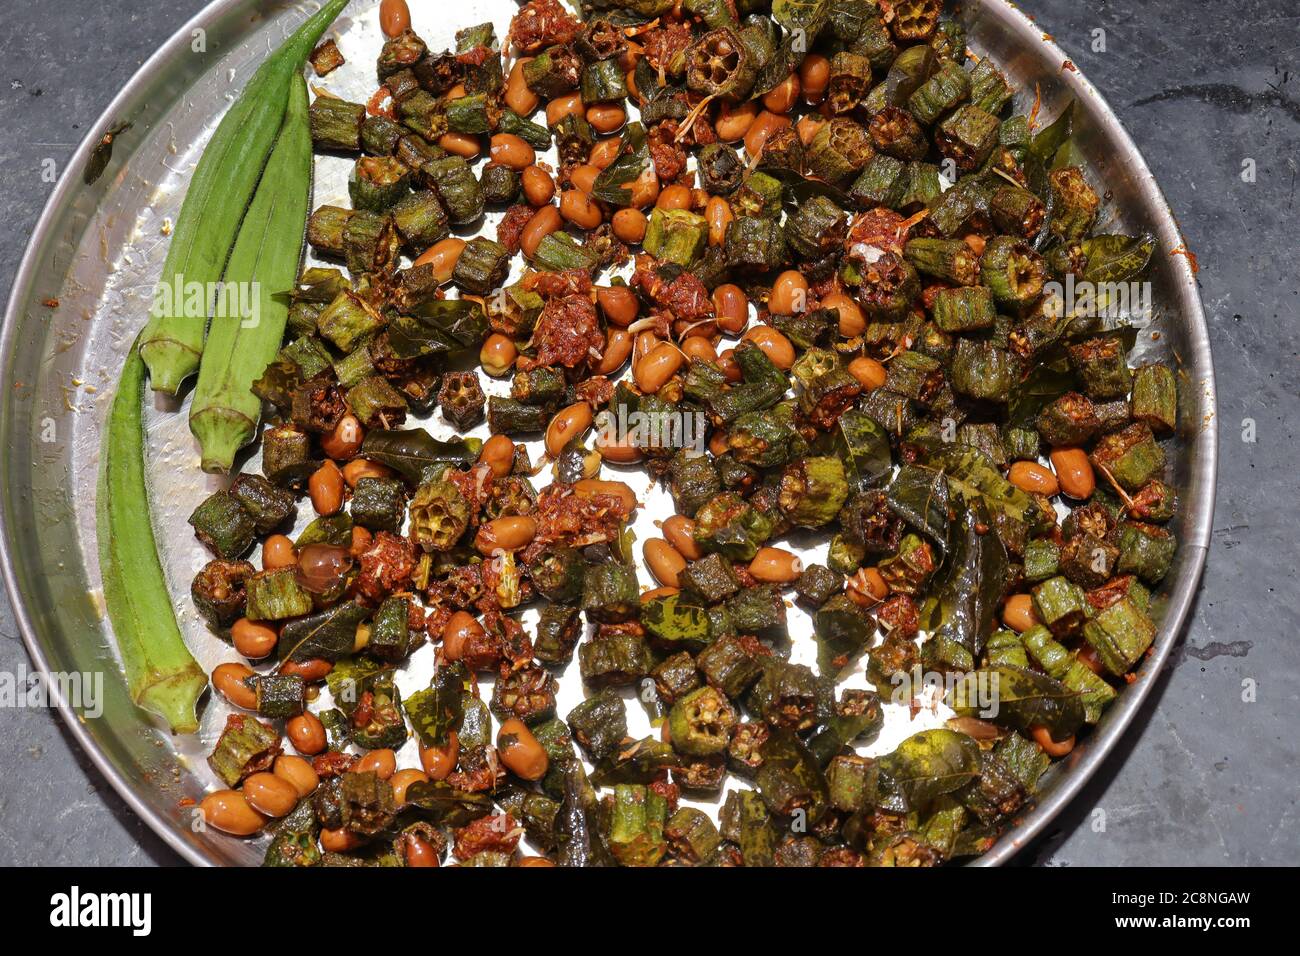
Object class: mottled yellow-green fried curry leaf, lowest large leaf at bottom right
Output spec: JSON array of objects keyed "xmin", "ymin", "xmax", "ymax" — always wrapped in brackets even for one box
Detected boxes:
[{"xmin": 868, "ymin": 727, "xmax": 980, "ymax": 813}]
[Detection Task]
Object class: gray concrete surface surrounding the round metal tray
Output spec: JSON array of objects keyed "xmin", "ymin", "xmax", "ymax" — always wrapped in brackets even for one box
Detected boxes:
[{"xmin": 0, "ymin": 0, "xmax": 1300, "ymax": 866}]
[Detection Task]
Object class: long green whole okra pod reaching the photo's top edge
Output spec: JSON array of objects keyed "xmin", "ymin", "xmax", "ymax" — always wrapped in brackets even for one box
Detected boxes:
[{"xmin": 139, "ymin": 0, "xmax": 347, "ymax": 394}]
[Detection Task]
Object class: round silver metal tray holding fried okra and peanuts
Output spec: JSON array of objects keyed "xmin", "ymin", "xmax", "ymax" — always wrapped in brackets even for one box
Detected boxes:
[{"xmin": 0, "ymin": 0, "xmax": 1216, "ymax": 865}]
